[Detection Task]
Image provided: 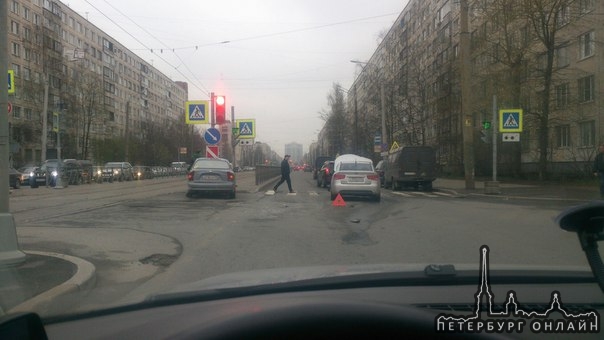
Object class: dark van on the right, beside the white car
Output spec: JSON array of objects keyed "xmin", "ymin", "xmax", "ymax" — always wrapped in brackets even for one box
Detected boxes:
[{"xmin": 384, "ymin": 146, "xmax": 436, "ymax": 190}]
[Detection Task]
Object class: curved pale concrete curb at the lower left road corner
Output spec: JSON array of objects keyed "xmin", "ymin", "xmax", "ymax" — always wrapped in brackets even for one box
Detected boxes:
[{"xmin": 8, "ymin": 250, "xmax": 96, "ymax": 314}]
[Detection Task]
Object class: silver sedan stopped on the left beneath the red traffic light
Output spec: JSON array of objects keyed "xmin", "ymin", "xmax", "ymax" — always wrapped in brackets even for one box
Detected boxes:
[{"xmin": 187, "ymin": 158, "xmax": 237, "ymax": 198}]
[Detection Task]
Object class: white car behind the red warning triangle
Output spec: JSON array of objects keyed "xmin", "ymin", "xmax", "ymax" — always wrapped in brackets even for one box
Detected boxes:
[{"xmin": 330, "ymin": 155, "xmax": 381, "ymax": 202}]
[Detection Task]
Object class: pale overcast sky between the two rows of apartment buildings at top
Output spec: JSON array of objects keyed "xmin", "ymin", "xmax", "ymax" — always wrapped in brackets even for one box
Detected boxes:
[{"xmin": 65, "ymin": 0, "xmax": 407, "ymax": 155}]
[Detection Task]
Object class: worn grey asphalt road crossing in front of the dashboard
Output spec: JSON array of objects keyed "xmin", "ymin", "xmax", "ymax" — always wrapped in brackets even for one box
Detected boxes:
[{"xmin": 10, "ymin": 172, "xmax": 586, "ymax": 312}]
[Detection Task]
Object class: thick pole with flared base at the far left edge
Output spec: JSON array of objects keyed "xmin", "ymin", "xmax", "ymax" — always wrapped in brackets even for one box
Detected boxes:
[{"xmin": 0, "ymin": 1, "xmax": 25, "ymax": 266}]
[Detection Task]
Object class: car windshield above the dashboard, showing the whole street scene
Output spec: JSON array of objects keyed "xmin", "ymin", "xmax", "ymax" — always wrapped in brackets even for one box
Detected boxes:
[{"xmin": 0, "ymin": 0, "xmax": 604, "ymax": 332}]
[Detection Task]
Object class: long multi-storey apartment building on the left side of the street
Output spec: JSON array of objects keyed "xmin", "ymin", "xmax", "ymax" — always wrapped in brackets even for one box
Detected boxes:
[{"xmin": 6, "ymin": 0, "xmax": 188, "ymax": 164}]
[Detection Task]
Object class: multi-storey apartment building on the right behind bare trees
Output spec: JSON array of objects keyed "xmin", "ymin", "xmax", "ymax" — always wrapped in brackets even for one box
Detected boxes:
[{"xmin": 347, "ymin": 0, "xmax": 604, "ymax": 175}]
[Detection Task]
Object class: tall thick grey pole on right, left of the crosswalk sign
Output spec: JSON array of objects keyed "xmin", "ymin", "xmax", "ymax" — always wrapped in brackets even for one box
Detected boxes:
[{"xmin": 459, "ymin": 0, "xmax": 475, "ymax": 189}]
